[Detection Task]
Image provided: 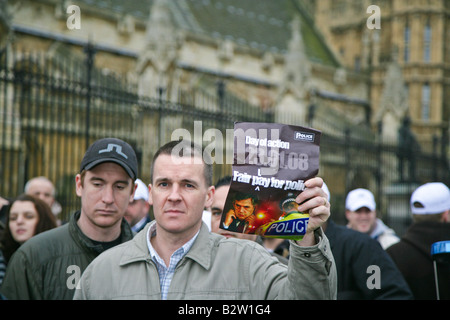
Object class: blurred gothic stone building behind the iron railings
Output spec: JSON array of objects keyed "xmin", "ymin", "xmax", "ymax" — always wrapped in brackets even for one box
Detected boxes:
[{"xmin": 0, "ymin": 0, "xmax": 450, "ymax": 228}]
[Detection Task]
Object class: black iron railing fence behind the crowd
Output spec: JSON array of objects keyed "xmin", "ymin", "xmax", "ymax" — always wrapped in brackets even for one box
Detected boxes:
[{"xmin": 0, "ymin": 49, "xmax": 450, "ymax": 233}]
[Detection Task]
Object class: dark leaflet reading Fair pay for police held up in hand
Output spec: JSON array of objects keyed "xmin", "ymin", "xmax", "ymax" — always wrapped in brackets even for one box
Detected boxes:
[{"xmin": 220, "ymin": 122, "xmax": 321, "ymax": 240}]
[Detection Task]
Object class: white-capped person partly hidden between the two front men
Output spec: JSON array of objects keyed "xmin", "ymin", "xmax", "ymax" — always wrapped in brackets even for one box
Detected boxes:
[{"xmin": 125, "ymin": 179, "xmax": 151, "ymax": 233}]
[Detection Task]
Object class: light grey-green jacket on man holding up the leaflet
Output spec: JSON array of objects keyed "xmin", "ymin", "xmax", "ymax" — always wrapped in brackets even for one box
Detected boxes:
[{"xmin": 74, "ymin": 222, "xmax": 337, "ymax": 300}]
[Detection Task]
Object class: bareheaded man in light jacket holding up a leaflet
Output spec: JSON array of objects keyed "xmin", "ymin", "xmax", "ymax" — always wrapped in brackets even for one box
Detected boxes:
[{"xmin": 74, "ymin": 140, "xmax": 337, "ymax": 301}]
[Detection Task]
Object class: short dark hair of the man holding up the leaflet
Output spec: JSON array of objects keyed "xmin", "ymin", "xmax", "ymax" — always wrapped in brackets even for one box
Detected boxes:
[{"xmin": 150, "ymin": 139, "xmax": 212, "ymax": 186}]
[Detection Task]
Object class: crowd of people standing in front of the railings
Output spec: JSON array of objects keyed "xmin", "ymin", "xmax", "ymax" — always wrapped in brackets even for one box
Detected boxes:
[{"xmin": 0, "ymin": 138, "xmax": 450, "ymax": 300}]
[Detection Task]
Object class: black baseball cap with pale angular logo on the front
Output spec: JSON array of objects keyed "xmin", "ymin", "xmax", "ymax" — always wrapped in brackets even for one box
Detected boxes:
[{"xmin": 80, "ymin": 138, "xmax": 138, "ymax": 181}]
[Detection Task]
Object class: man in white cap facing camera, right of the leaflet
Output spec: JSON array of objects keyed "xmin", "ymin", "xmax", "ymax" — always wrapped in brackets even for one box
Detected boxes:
[{"xmin": 345, "ymin": 188, "xmax": 400, "ymax": 249}]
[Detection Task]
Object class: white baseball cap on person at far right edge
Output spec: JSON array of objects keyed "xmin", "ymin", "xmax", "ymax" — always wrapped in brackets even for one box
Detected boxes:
[{"xmin": 410, "ymin": 182, "xmax": 450, "ymax": 214}]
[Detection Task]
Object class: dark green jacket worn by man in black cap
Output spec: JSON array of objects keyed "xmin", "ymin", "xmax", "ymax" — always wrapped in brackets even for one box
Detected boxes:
[{"xmin": 0, "ymin": 211, "xmax": 133, "ymax": 300}]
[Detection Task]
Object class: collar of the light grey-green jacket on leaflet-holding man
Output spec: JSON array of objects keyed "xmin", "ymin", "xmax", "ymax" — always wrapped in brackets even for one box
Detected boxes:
[{"xmin": 119, "ymin": 221, "xmax": 213, "ymax": 269}]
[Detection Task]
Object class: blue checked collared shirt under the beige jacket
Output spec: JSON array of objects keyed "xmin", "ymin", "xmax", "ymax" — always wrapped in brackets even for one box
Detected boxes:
[{"xmin": 147, "ymin": 223, "xmax": 200, "ymax": 300}]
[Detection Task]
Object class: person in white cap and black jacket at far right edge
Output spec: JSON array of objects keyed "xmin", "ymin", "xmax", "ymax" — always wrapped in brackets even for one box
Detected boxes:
[{"xmin": 387, "ymin": 182, "xmax": 450, "ymax": 300}]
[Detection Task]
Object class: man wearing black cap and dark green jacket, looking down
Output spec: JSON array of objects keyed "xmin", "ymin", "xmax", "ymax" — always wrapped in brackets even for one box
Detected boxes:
[{"xmin": 0, "ymin": 138, "xmax": 137, "ymax": 299}]
